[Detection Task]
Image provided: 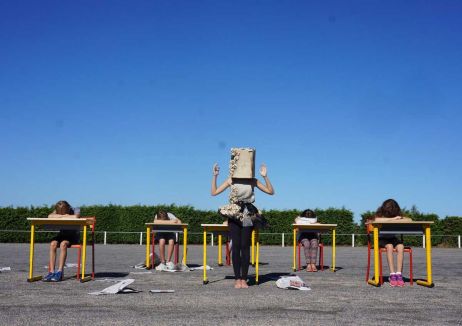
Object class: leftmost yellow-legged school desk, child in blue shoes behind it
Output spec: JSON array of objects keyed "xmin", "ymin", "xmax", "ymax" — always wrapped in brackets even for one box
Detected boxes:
[{"xmin": 27, "ymin": 217, "xmax": 95, "ymax": 282}]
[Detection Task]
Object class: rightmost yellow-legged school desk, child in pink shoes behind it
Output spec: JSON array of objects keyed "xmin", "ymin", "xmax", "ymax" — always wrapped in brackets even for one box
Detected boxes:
[{"xmin": 367, "ymin": 220, "xmax": 434, "ymax": 287}]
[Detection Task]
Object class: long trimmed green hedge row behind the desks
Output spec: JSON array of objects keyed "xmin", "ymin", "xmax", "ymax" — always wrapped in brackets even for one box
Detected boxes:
[{"xmin": 0, "ymin": 205, "xmax": 462, "ymax": 246}]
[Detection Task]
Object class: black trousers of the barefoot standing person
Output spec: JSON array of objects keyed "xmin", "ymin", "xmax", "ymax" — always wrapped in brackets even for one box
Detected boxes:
[{"xmin": 228, "ymin": 219, "xmax": 253, "ymax": 280}]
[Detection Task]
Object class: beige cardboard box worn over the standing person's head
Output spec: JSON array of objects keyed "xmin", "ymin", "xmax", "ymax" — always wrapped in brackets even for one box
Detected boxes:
[{"xmin": 229, "ymin": 148, "xmax": 256, "ymax": 179}]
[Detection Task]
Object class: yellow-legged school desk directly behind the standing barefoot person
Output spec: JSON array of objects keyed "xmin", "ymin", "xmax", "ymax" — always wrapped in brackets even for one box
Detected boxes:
[{"xmin": 201, "ymin": 224, "xmax": 260, "ymax": 284}]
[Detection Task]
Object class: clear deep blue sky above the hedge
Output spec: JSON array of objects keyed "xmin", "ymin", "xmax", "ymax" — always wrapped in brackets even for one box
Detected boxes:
[{"xmin": 0, "ymin": 0, "xmax": 462, "ymax": 222}]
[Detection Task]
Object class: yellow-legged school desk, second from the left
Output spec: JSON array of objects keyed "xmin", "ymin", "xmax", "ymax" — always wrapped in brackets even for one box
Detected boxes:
[{"xmin": 145, "ymin": 222, "xmax": 188, "ymax": 269}]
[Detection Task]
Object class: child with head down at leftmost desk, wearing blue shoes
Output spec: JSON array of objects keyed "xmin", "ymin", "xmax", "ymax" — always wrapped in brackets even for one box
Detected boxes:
[{"xmin": 43, "ymin": 200, "xmax": 80, "ymax": 282}]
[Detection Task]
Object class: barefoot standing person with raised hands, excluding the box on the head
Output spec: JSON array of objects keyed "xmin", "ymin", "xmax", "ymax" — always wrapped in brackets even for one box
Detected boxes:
[{"xmin": 211, "ymin": 149, "xmax": 274, "ymax": 289}]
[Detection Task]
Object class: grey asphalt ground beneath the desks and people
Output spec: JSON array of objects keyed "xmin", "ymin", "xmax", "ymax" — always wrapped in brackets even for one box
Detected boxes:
[{"xmin": 0, "ymin": 244, "xmax": 462, "ymax": 325}]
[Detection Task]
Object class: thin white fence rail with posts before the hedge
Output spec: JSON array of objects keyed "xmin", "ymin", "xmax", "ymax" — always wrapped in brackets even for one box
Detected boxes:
[{"xmin": 0, "ymin": 230, "xmax": 462, "ymax": 249}]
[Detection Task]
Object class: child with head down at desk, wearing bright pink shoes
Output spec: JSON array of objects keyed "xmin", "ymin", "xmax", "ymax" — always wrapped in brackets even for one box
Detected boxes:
[{"xmin": 373, "ymin": 199, "xmax": 412, "ymax": 287}]
